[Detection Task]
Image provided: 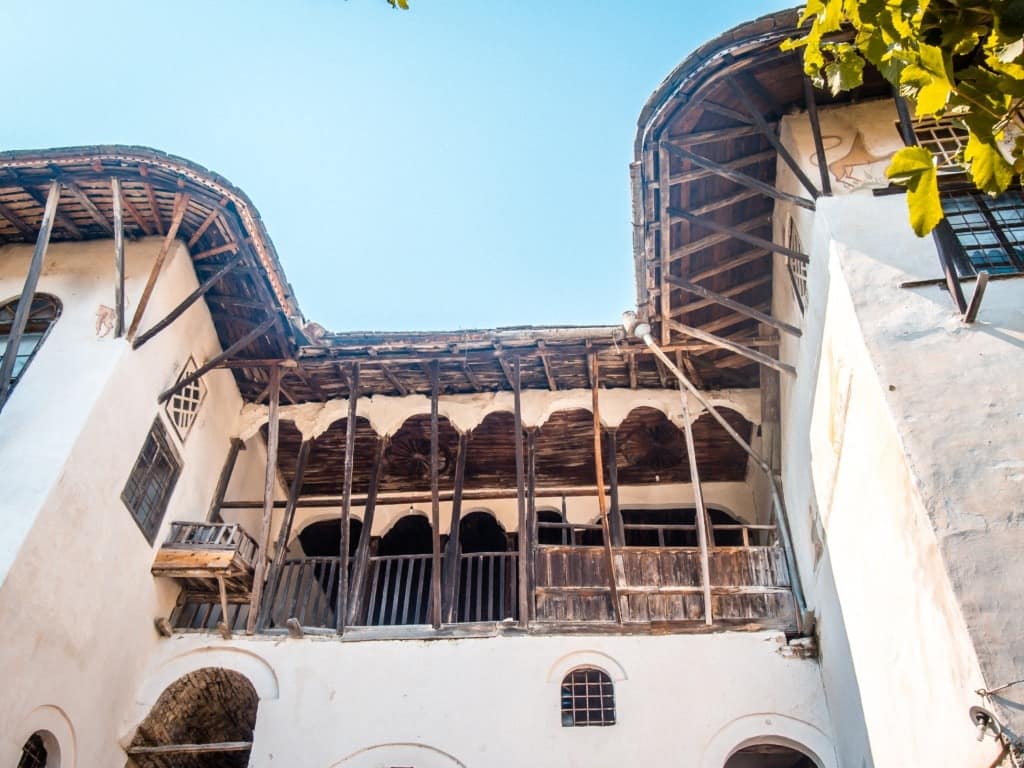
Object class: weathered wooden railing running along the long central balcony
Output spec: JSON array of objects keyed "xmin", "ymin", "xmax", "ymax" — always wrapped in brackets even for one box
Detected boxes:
[{"xmin": 163, "ymin": 523, "xmax": 797, "ymax": 632}]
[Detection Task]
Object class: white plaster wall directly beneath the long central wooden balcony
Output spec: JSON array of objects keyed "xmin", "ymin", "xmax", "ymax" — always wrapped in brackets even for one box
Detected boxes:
[{"xmin": 130, "ymin": 632, "xmax": 836, "ymax": 768}]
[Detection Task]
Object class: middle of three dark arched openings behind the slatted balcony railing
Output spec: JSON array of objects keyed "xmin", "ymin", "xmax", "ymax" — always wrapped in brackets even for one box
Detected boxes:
[{"xmin": 367, "ymin": 513, "xmax": 433, "ymax": 626}]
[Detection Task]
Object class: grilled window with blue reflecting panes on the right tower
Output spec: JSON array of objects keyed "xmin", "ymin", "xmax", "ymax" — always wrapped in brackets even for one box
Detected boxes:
[{"xmin": 942, "ymin": 189, "xmax": 1024, "ymax": 275}]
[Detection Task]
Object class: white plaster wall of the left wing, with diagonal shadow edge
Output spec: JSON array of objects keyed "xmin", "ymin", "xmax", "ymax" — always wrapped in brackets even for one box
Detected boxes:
[{"xmin": 0, "ymin": 240, "xmax": 272, "ymax": 768}]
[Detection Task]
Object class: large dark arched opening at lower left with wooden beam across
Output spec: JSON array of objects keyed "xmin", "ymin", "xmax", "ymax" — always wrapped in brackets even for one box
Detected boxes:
[{"xmin": 127, "ymin": 667, "xmax": 259, "ymax": 768}]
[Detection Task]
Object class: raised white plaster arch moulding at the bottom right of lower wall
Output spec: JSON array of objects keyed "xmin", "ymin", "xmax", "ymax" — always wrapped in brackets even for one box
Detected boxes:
[{"xmin": 700, "ymin": 712, "xmax": 839, "ymax": 768}]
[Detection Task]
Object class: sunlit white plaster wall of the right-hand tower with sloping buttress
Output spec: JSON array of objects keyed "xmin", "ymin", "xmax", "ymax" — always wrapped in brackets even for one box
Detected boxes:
[{"xmin": 774, "ymin": 107, "xmax": 1011, "ymax": 766}]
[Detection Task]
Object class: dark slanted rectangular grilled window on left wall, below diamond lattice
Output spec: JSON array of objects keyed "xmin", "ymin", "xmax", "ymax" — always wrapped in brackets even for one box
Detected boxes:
[{"xmin": 121, "ymin": 417, "xmax": 181, "ymax": 544}]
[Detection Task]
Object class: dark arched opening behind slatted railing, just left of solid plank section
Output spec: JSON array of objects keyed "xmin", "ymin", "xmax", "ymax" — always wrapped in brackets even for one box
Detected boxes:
[{"xmin": 455, "ymin": 510, "xmax": 516, "ymax": 622}]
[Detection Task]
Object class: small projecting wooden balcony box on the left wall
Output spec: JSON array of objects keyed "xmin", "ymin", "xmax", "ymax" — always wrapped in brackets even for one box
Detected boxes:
[{"xmin": 152, "ymin": 522, "xmax": 256, "ymax": 593}]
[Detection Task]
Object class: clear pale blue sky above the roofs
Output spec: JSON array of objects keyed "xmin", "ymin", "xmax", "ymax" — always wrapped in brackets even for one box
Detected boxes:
[{"xmin": 0, "ymin": 0, "xmax": 784, "ymax": 331}]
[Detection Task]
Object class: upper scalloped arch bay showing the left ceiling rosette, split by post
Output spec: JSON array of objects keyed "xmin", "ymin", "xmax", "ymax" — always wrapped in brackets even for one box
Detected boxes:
[{"xmin": 380, "ymin": 414, "xmax": 459, "ymax": 492}]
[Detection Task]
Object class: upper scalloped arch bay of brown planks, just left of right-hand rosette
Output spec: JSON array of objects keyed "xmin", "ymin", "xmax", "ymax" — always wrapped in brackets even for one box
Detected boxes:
[{"xmin": 537, "ymin": 409, "xmax": 597, "ymax": 487}]
